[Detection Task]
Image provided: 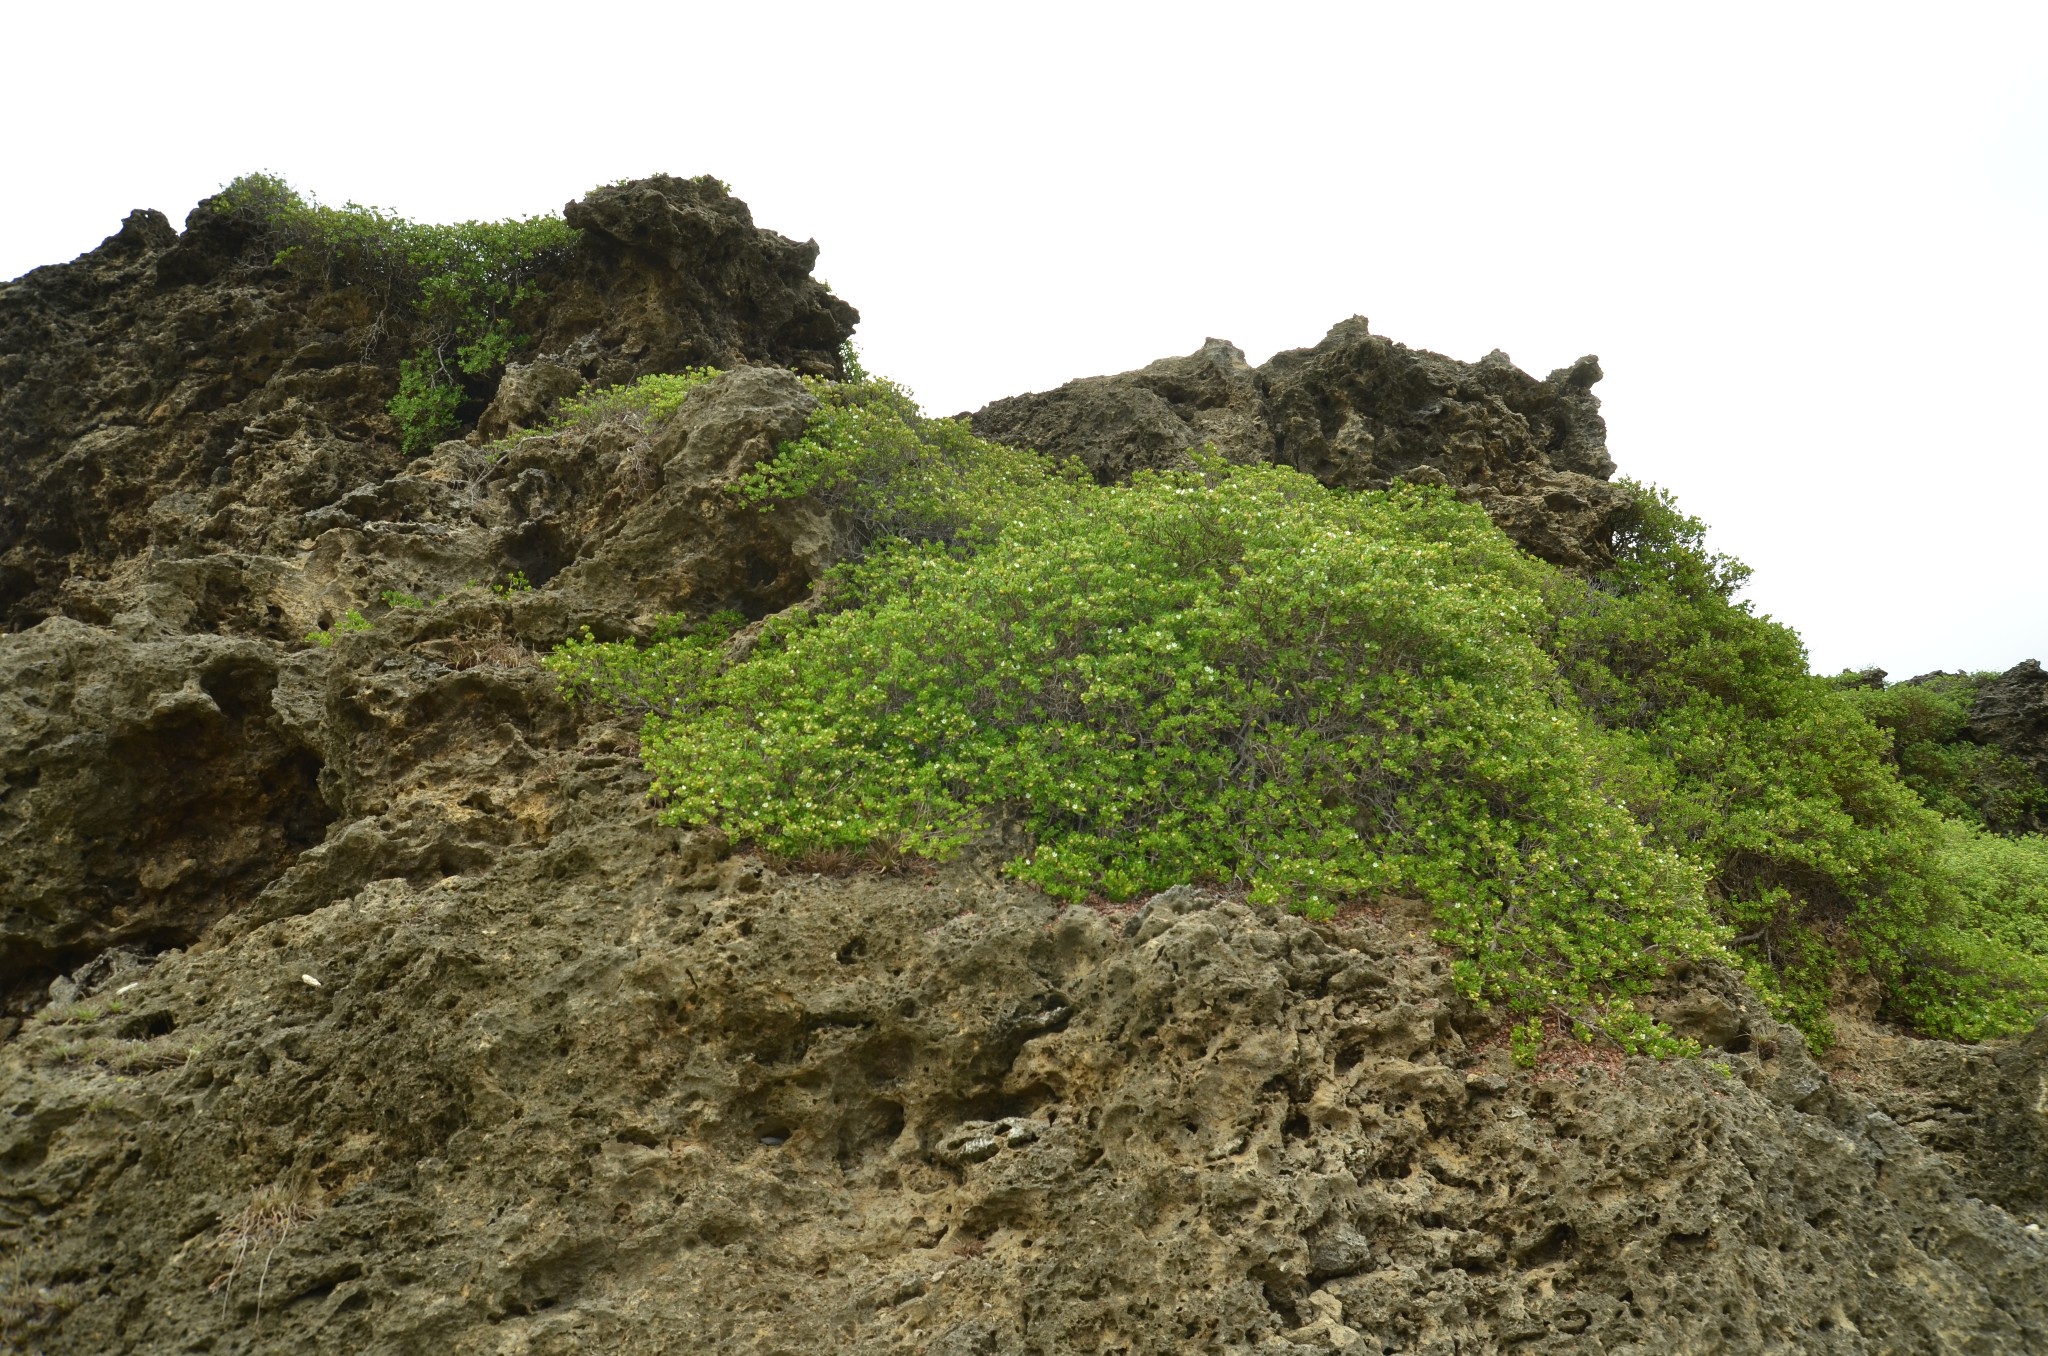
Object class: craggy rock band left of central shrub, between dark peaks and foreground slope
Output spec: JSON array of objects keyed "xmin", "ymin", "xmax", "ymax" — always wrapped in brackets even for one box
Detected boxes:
[{"xmin": 0, "ymin": 367, "xmax": 842, "ymax": 1008}]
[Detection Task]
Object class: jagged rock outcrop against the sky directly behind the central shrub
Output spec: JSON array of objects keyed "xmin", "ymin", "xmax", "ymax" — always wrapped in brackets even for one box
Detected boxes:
[{"xmin": 971, "ymin": 315, "xmax": 1630, "ymax": 569}]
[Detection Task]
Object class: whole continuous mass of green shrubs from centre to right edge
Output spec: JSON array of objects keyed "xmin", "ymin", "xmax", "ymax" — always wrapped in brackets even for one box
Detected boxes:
[{"xmin": 549, "ymin": 369, "xmax": 2048, "ymax": 1057}]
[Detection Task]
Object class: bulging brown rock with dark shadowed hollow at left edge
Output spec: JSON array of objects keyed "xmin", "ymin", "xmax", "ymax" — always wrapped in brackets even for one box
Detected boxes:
[{"xmin": 0, "ymin": 617, "xmax": 332, "ymax": 1008}]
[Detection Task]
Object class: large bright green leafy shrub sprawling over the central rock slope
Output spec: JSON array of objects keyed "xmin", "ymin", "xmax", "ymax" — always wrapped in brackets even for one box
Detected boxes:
[{"xmin": 645, "ymin": 449, "xmax": 1716, "ymax": 1045}]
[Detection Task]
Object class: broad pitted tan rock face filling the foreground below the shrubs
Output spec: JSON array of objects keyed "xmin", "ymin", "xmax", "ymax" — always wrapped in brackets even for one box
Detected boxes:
[{"xmin": 0, "ymin": 856, "xmax": 2048, "ymax": 1354}]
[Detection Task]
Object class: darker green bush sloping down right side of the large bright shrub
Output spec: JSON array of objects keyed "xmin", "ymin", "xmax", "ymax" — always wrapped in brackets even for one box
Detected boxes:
[{"xmin": 1550, "ymin": 488, "xmax": 2048, "ymax": 1043}]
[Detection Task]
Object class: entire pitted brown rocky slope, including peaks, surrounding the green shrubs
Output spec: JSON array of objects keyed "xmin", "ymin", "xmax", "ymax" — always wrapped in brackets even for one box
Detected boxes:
[{"xmin": 0, "ymin": 178, "xmax": 2048, "ymax": 1356}]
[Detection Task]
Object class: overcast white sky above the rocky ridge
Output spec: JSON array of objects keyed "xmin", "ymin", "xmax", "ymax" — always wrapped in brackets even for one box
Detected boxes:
[{"xmin": 0, "ymin": 0, "xmax": 2048, "ymax": 676}]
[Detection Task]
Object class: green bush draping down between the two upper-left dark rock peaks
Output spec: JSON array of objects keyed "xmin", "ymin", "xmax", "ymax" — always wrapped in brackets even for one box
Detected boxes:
[{"xmin": 213, "ymin": 174, "xmax": 578, "ymax": 453}]
